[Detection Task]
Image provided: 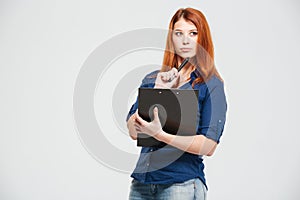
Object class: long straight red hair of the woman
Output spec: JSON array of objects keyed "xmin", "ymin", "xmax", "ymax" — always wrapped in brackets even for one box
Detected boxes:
[{"xmin": 161, "ymin": 8, "xmax": 222, "ymax": 86}]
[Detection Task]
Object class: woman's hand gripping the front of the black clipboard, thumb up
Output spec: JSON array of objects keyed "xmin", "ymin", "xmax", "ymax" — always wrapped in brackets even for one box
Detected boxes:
[{"xmin": 134, "ymin": 107, "xmax": 163, "ymax": 137}]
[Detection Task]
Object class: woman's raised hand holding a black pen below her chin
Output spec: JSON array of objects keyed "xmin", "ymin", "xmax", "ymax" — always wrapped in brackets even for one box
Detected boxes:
[{"xmin": 154, "ymin": 67, "xmax": 180, "ymax": 88}]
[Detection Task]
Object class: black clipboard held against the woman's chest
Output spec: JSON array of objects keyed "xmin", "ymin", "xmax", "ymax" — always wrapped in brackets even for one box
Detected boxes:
[{"xmin": 137, "ymin": 88, "xmax": 199, "ymax": 147}]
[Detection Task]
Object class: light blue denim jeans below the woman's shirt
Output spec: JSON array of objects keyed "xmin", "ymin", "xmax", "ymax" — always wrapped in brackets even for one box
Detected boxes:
[{"xmin": 129, "ymin": 178, "xmax": 207, "ymax": 200}]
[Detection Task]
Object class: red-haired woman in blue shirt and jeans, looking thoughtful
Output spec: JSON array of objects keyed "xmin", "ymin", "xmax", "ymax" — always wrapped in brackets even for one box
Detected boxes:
[{"xmin": 127, "ymin": 8, "xmax": 227, "ymax": 200}]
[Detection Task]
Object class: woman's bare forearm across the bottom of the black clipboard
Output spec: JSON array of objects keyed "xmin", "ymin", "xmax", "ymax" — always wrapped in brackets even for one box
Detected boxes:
[{"xmin": 155, "ymin": 131, "xmax": 217, "ymax": 156}]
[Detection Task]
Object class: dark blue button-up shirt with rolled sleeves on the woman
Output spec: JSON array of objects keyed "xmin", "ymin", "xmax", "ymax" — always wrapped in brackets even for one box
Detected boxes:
[{"xmin": 127, "ymin": 70, "xmax": 227, "ymax": 189}]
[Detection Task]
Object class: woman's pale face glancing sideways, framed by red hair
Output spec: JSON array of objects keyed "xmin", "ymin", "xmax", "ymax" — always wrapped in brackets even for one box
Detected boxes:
[{"xmin": 172, "ymin": 17, "xmax": 198, "ymax": 58}]
